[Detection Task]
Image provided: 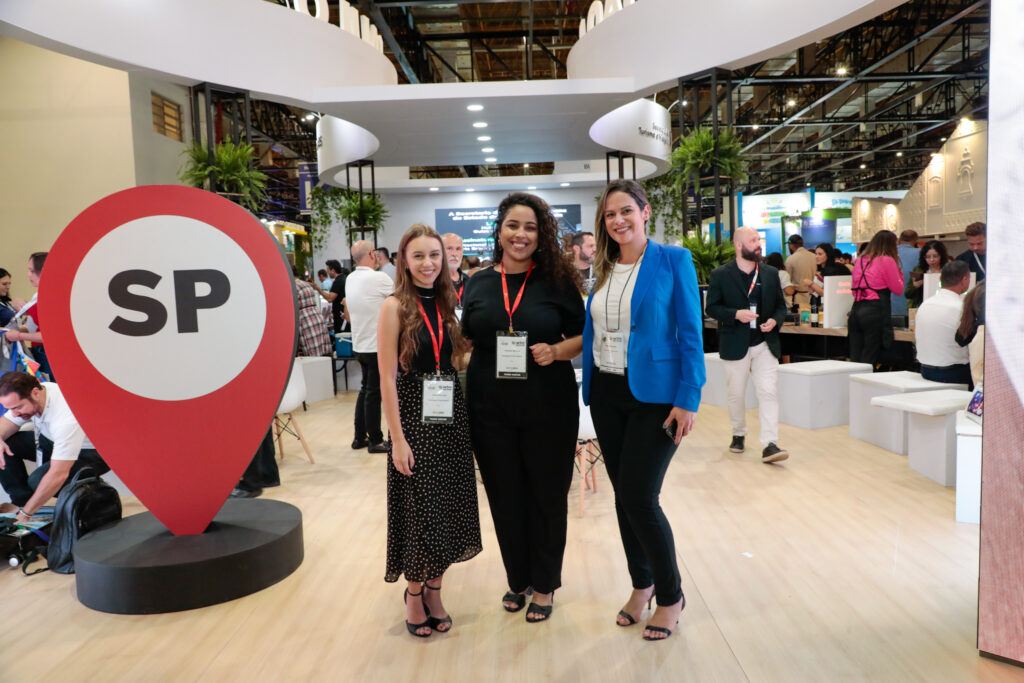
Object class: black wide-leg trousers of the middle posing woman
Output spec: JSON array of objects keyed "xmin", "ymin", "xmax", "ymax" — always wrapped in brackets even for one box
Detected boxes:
[{"xmin": 470, "ymin": 389, "xmax": 580, "ymax": 593}]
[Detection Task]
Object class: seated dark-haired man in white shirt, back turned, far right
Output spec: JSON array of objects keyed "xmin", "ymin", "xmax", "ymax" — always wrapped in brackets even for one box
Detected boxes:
[{"xmin": 914, "ymin": 261, "xmax": 974, "ymax": 389}]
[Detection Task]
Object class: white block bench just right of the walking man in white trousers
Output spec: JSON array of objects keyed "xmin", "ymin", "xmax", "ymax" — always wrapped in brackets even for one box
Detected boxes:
[{"xmin": 778, "ymin": 360, "xmax": 871, "ymax": 429}]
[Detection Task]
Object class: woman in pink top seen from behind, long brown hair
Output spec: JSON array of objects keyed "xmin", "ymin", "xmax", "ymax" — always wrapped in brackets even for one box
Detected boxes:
[{"xmin": 849, "ymin": 230, "xmax": 903, "ymax": 366}]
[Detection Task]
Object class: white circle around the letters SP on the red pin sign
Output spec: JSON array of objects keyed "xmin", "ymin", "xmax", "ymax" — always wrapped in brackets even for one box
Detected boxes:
[{"xmin": 71, "ymin": 216, "xmax": 266, "ymax": 400}]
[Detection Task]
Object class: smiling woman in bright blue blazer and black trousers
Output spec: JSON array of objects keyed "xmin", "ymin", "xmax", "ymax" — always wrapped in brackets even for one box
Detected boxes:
[{"xmin": 583, "ymin": 180, "xmax": 705, "ymax": 640}]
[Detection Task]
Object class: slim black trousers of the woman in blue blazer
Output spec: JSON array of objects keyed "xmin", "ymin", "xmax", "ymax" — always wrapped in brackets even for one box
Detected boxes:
[{"xmin": 590, "ymin": 372, "xmax": 683, "ymax": 605}]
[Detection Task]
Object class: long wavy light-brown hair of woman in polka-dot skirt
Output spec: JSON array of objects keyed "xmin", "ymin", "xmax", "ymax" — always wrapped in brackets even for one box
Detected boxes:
[{"xmin": 394, "ymin": 223, "xmax": 468, "ymax": 372}]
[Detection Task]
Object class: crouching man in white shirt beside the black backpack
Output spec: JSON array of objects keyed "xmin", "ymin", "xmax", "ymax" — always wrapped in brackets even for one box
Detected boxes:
[{"xmin": 0, "ymin": 372, "xmax": 111, "ymax": 521}]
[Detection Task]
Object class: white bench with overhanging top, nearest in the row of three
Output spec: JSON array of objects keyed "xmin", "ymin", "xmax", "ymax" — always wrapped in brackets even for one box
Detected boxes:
[{"xmin": 871, "ymin": 389, "xmax": 974, "ymax": 486}]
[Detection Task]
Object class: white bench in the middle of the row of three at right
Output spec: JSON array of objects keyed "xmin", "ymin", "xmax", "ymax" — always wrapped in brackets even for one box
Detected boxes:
[{"xmin": 850, "ymin": 371, "xmax": 967, "ymax": 456}]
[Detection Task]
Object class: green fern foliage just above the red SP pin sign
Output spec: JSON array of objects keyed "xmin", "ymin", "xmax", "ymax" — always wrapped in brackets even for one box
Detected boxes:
[{"xmin": 178, "ymin": 141, "xmax": 267, "ymax": 213}]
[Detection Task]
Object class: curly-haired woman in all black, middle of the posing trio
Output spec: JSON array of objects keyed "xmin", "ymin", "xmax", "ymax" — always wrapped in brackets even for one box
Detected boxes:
[{"xmin": 462, "ymin": 194, "xmax": 585, "ymax": 623}]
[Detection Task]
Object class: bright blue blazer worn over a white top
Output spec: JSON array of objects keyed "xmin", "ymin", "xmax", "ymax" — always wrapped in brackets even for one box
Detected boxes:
[{"xmin": 583, "ymin": 240, "xmax": 705, "ymax": 413}]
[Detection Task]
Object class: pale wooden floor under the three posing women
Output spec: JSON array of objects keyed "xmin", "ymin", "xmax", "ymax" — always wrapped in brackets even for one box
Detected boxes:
[{"xmin": 0, "ymin": 393, "xmax": 1024, "ymax": 683}]
